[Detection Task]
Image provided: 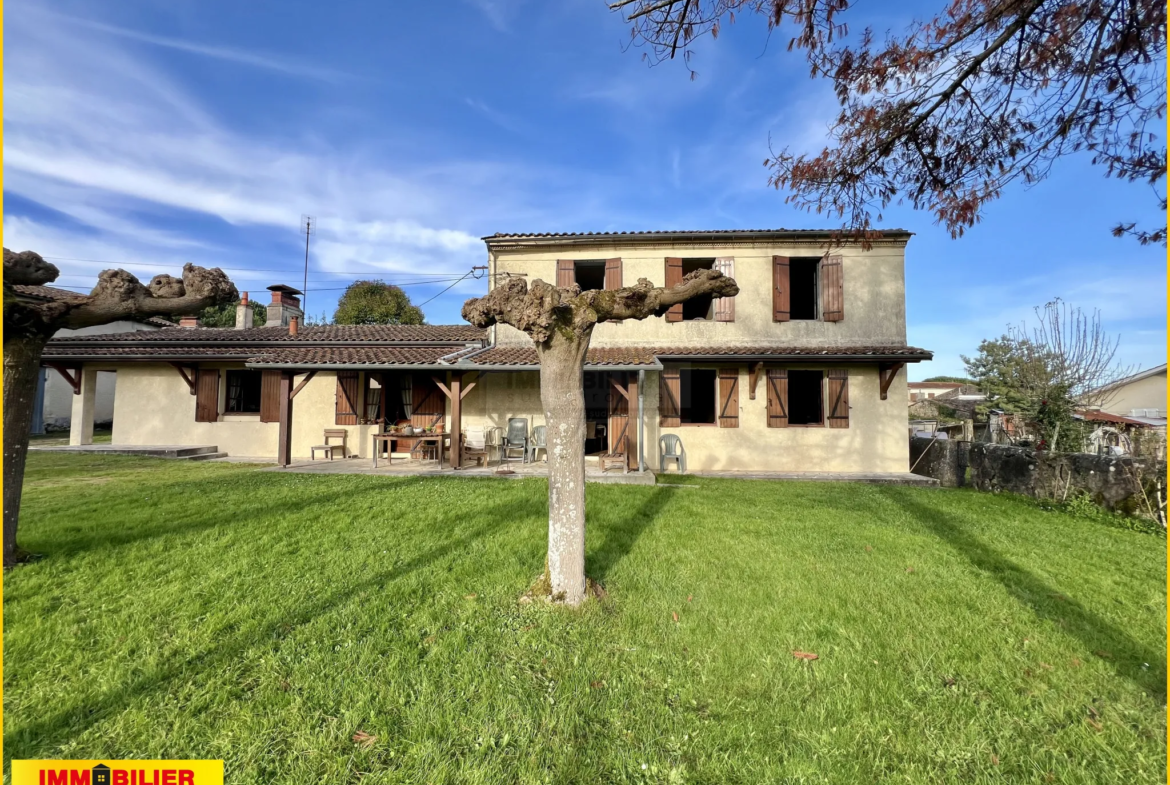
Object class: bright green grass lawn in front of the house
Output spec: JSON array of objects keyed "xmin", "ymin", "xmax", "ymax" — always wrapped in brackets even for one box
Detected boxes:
[{"xmin": 4, "ymin": 454, "xmax": 1166, "ymax": 785}]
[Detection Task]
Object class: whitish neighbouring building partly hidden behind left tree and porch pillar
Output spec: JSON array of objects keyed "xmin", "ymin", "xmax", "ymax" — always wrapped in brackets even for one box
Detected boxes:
[{"xmin": 14, "ymin": 285, "xmax": 174, "ymax": 433}]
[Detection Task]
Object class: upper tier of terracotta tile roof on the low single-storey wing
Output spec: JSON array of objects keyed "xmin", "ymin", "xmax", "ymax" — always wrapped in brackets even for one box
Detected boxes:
[{"xmin": 57, "ymin": 324, "xmax": 487, "ymax": 344}]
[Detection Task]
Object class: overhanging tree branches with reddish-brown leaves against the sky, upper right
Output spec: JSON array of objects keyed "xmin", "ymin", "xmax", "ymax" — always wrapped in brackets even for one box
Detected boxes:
[{"xmin": 610, "ymin": 0, "xmax": 1166, "ymax": 246}]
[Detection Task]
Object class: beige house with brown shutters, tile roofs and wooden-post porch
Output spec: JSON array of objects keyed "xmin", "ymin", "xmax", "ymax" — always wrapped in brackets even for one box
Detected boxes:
[{"xmin": 47, "ymin": 229, "xmax": 931, "ymax": 473}]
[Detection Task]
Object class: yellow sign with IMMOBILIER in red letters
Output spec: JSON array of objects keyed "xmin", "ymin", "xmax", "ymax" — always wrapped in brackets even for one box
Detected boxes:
[{"xmin": 12, "ymin": 760, "xmax": 223, "ymax": 785}]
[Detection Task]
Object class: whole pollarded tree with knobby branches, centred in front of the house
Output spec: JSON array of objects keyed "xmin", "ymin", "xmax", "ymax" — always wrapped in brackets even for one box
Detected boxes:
[{"xmin": 463, "ymin": 270, "xmax": 739, "ymax": 605}]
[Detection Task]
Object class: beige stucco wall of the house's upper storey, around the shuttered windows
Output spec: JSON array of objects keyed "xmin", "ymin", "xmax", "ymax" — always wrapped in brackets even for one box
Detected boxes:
[{"xmin": 489, "ymin": 242, "xmax": 906, "ymax": 346}]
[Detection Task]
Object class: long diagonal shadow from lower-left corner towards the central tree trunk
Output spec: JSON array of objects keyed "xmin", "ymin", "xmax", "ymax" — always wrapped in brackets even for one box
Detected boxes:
[{"xmin": 5, "ymin": 491, "xmax": 543, "ymax": 759}]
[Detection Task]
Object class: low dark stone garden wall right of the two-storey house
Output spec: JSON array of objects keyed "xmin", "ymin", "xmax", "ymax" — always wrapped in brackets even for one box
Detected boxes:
[{"xmin": 910, "ymin": 436, "xmax": 1166, "ymax": 512}]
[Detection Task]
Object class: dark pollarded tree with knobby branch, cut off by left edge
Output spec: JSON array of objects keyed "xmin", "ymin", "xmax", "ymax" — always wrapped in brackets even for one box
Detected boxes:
[{"xmin": 4, "ymin": 248, "xmax": 239, "ymax": 567}]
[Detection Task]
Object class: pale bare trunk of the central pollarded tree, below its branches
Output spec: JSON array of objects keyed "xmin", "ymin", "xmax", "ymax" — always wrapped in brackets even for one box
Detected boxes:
[{"xmin": 537, "ymin": 330, "xmax": 593, "ymax": 606}]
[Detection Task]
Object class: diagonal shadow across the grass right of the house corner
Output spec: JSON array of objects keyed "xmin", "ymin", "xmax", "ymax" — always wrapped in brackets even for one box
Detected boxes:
[{"xmin": 883, "ymin": 488, "xmax": 1166, "ymax": 702}]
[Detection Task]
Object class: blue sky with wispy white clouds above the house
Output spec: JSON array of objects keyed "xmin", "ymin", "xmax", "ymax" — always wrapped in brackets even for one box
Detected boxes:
[{"xmin": 4, "ymin": 0, "xmax": 1166, "ymax": 378}]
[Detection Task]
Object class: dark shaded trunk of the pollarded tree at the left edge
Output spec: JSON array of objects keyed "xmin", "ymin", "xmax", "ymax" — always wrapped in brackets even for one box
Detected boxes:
[{"xmin": 4, "ymin": 336, "xmax": 46, "ymax": 567}]
